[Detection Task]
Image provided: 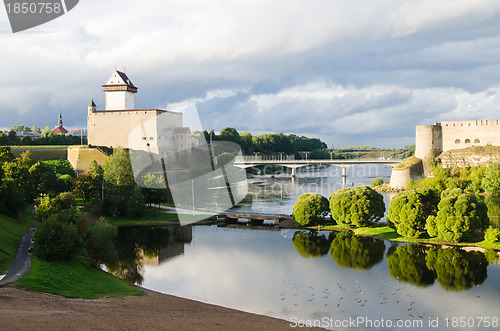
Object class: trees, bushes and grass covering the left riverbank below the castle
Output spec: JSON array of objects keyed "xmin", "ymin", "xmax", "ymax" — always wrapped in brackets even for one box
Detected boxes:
[{"xmin": 0, "ymin": 146, "xmax": 155, "ymax": 298}]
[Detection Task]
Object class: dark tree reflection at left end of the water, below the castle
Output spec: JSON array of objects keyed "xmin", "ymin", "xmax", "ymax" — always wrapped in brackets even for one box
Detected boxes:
[{"xmin": 106, "ymin": 227, "xmax": 169, "ymax": 285}]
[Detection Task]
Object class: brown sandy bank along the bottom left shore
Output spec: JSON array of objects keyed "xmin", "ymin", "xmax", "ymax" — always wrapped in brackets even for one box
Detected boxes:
[{"xmin": 0, "ymin": 285, "xmax": 324, "ymax": 330}]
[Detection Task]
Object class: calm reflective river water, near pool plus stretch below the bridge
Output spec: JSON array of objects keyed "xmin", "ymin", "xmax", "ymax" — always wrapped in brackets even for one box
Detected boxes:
[{"xmin": 110, "ymin": 166, "xmax": 500, "ymax": 330}]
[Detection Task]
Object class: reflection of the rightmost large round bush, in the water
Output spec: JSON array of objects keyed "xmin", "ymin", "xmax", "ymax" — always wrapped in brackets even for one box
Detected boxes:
[{"xmin": 425, "ymin": 248, "xmax": 488, "ymax": 291}]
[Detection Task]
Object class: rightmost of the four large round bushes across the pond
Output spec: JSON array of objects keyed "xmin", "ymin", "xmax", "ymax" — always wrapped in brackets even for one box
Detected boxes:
[{"xmin": 426, "ymin": 192, "xmax": 489, "ymax": 242}]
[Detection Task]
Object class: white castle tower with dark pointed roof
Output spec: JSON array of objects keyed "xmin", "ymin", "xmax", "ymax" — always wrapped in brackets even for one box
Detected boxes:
[{"xmin": 102, "ymin": 69, "xmax": 137, "ymax": 110}]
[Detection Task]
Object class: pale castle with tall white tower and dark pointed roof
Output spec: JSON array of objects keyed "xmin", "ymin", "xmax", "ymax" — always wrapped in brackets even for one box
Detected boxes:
[{"xmin": 87, "ymin": 70, "xmax": 191, "ymax": 157}]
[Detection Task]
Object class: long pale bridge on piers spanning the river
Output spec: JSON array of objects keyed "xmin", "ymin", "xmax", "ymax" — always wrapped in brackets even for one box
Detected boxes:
[{"xmin": 234, "ymin": 156, "xmax": 403, "ymax": 186}]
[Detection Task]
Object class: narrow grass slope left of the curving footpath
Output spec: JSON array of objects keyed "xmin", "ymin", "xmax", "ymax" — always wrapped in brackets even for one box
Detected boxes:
[{"xmin": 0, "ymin": 207, "xmax": 33, "ymax": 275}]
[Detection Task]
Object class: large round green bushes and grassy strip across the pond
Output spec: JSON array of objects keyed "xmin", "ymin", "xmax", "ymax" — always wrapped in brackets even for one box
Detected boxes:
[{"xmin": 294, "ymin": 174, "xmax": 500, "ymax": 249}]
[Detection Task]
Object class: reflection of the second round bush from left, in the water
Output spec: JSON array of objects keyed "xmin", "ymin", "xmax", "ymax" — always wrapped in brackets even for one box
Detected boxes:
[{"xmin": 330, "ymin": 231, "xmax": 385, "ymax": 270}]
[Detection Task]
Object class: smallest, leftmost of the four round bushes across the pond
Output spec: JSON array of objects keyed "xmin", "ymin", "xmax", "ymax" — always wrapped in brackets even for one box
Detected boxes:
[{"xmin": 293, "ymin": 193, "xmax": 328, "ymax": 225}]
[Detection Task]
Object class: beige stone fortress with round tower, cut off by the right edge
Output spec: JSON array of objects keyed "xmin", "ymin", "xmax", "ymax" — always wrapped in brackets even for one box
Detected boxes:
[{"xmin": 415, "ymin": 120, "xmax": 500, "ymax": 160}]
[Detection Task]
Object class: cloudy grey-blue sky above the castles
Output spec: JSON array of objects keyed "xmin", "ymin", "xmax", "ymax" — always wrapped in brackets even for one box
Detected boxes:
[{"xmin": 0, "ymin": 0, "xmax": 500, "ymax": 147}]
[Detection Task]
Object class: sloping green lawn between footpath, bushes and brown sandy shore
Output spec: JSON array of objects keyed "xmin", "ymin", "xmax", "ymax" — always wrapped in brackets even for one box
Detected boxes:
[{"xmin": 15, "ymin": 256, "xmax": 144, "ymax": 299}]
